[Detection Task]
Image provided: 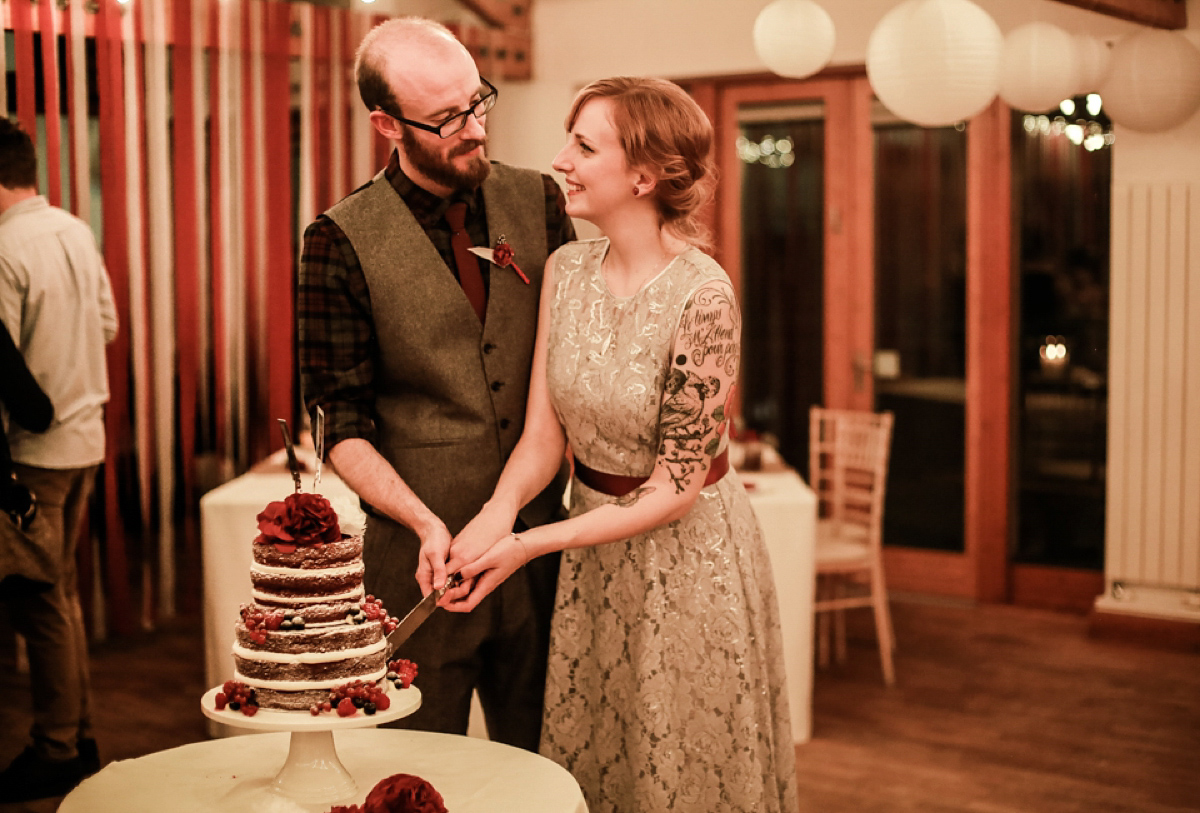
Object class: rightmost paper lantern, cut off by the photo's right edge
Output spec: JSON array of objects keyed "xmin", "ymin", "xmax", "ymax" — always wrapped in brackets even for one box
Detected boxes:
[{"xmin": 1100, "ymin": 29, "xmax": 1200, "ymax": 133}]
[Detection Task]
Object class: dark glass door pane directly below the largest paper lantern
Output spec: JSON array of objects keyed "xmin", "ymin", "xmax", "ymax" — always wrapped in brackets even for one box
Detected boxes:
[{"xmin": 871, "ymin": 102, "xmax": 967, "ymax": 553}]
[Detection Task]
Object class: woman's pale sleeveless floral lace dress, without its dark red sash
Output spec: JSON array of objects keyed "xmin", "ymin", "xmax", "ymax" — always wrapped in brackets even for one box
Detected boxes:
[{"xmin": 541, "ymin": 240, "xmax": 798, "ymax": 813}]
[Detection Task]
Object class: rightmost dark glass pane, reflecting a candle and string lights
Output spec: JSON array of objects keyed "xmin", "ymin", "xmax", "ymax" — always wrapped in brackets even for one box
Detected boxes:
[{"xmin": 1012, "ymin": 103, "xmax": 1112, "ymax": 570}]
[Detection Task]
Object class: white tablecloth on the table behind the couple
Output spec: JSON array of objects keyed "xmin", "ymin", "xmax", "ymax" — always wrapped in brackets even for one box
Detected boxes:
[{"xmin": 200, "ymin": 470, "xmax": 816, "ymax": 743}]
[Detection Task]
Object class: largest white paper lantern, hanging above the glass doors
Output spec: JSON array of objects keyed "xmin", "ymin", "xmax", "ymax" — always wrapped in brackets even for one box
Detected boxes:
[{"xmin": 866, "ymin": 0, "xmax": 1004, "ymax": 127}]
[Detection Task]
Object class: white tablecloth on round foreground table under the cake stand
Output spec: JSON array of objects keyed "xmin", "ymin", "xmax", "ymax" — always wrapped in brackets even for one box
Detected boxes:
[{"xmin": 59, "ymin": 729, "xmax": 587, "ymax": 813}]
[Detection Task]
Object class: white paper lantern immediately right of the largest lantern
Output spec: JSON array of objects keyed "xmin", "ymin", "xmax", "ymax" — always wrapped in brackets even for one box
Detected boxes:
[{"xmin": 1000, "ymin": 23, "xmax": 1079, "ymax": 113}]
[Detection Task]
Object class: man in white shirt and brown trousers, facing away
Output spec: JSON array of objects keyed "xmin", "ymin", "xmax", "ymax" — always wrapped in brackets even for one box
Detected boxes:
[{"xmin": 0, "ymin": 119, "xmax": 116, "ymax": 802}]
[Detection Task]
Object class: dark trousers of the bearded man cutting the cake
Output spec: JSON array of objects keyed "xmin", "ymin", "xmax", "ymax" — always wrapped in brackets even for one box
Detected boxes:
[{"xmin": 362, "ymin": 517, "xmax": 559, "ymax": 752}]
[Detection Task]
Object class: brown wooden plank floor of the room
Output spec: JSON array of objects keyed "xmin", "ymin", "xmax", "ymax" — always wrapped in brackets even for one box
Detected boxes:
[{"xmin": 0, "ymin": 597, "xmax": 1200, "ymax": 813}]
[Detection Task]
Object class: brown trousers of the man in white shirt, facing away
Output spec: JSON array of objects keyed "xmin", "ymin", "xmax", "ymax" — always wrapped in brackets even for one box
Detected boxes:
[{"xmin": 4, "ymin": 463, "xmax": 97, "ymax": 760}]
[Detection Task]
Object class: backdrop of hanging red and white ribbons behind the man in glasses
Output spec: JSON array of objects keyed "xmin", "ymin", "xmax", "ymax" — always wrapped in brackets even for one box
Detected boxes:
[{"xmin": 0, "ymin": 0, "xmax": 386, "ymax": 637}]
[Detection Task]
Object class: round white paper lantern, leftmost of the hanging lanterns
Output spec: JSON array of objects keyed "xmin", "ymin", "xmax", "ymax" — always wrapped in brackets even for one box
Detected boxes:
[{"xmin": 754, "ymin": 0, "xmax": 834, "ymax": 79}]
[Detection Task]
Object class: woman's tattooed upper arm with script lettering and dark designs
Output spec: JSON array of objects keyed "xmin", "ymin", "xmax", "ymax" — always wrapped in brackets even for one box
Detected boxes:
[{"xmin": 659, "ymin": 287, "xmax": 740, "ymax": 493}]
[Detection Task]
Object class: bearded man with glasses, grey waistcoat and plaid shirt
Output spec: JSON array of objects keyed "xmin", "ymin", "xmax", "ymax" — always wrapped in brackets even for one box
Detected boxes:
[{"xmin": 298, "ymin": 17, "xmax": 575, "ymax": 751}]
